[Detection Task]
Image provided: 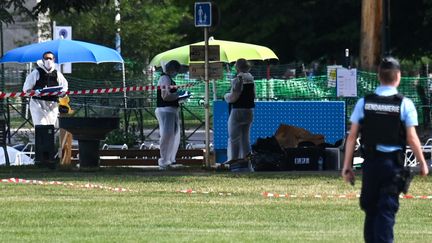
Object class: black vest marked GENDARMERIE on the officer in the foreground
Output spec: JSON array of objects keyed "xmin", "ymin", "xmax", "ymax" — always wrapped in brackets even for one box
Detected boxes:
[{"xmin": 360, "ymin": 94, "xmax": 406, "ymax": 149}]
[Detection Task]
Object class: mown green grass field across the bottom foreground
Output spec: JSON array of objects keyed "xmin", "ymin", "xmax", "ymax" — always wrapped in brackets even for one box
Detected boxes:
[{"xmin": 0, "ymin": 167, "xmax": 432, "ymax": 242}]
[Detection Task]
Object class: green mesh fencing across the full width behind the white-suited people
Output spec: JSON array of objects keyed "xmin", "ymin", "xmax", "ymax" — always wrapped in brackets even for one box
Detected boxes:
[{"xmin": 3, "ymin": 66, "xmax": 432, "ymax": 124}]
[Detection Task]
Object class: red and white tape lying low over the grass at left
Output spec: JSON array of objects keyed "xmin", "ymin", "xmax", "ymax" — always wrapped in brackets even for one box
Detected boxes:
[{"xmin": 1, "ymin": 178, "xmax": 132, "ymax": 192}]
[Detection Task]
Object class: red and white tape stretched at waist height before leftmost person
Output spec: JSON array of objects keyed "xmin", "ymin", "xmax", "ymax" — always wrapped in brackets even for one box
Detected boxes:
[{"xmin": 0, "ymin": 82, "xmax": 196, "ymax": 99}]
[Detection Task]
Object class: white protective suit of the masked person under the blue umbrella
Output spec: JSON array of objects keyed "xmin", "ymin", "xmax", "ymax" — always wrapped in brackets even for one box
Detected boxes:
[{"xmin": 23, "ymin": 60, "xmax": 68, "ymax": 127}]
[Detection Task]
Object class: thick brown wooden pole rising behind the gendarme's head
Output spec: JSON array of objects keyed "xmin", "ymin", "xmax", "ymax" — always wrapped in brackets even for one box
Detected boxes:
[{"xmin": 360, "ymin": 0, "xmax": 383, "ymax": 71}]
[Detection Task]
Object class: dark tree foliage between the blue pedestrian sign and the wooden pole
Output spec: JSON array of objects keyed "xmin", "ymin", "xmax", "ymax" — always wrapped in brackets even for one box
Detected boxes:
[{"xmin": 191, "ymin": 0, "xmax": 360, "ymax": 63}]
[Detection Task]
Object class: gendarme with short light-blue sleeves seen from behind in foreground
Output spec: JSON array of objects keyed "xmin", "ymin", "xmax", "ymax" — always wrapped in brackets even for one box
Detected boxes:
[{"xmin": 342, "ymin": 57, "xmax": 428, "ymax": 242}]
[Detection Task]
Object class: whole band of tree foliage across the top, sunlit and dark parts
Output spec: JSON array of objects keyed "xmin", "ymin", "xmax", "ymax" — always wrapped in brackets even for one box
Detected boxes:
[{"xmin": 0, "ymin": 0, "xmax": 432, "ymax": 70}]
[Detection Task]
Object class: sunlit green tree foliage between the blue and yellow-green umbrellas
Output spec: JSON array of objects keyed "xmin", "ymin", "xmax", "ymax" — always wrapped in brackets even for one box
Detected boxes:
[{"xmin": 54, "ymin": 0, "xmax": 190, "ymax": 75}]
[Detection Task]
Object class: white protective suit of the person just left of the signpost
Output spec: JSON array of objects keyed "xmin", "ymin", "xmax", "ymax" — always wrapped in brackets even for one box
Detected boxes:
[{"xmin": 155, "ymin": 75, "xmax": 180, "ymax": 168}]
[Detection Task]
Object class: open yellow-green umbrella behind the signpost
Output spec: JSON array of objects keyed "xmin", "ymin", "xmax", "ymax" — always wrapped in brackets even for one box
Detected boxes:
[{"xmin": 150, "ymin": 37, "xmax": 278, "ymax": 67}]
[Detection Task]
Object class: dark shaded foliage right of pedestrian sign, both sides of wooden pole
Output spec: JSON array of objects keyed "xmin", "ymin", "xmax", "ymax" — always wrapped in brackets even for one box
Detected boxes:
[{"xmin": 179, "ymin": 0, "xmax": 432, "ymax": 63}]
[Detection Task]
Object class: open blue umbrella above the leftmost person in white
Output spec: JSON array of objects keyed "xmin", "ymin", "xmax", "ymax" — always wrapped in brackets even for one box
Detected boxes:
[{"xmin": 0, "ymin": 39, "xmax": 123, "ymax": 64}]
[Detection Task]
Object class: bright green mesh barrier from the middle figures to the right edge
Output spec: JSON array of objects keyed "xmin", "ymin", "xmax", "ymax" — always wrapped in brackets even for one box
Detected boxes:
[{"xmin": 171, "ymin": 71, "xmax": 430, "ymax": 124}]
